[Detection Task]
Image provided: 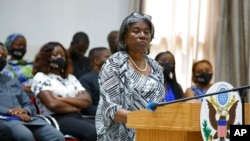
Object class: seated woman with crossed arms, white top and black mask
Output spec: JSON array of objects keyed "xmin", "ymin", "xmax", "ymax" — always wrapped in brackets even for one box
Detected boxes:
[{"xmin": 31, "ymin": 42, "xmax": 96, "ymax": 141}]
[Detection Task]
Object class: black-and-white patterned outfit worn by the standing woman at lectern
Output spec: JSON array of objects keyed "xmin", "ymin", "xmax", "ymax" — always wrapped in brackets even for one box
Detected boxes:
[{"xmin": 96, "ymin": 51, "xmax": 165, "ymax": 141}]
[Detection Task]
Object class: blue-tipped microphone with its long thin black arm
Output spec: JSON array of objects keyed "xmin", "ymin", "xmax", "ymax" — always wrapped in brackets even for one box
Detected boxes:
[{"xmin": 146, "ymin": 85, "xmax": 250, "ymax": 112}]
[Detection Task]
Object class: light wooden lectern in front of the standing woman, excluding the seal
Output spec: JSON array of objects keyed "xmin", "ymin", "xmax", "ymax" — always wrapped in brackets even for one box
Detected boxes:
[{"xmin": 127, "ymin": 102, "xmax": 250, "ymax": 141}]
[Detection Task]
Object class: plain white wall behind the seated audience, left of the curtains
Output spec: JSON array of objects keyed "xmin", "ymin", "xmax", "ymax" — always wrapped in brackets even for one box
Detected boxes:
[{"xmin": 0, "ymin": 0, "xmax": 135, "ymax": 60}]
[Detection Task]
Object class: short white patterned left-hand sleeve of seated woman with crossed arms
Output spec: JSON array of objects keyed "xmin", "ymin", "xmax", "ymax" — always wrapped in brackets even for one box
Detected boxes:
[{"xmin": 31, "ymin": 72, "xmax": 52, "ymax": 95}]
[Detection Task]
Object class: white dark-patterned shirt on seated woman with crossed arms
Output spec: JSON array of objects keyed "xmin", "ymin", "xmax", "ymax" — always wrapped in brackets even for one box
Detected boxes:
[{"xmin": 31, "ymin": 72, "xmax": 85, "ymax": 115}]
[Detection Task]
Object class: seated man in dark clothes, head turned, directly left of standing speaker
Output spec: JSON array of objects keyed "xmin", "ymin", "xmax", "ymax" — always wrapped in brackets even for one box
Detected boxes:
[{"xmin": 80, "ymin": 47, "xmax": 111, "ymax": 116}]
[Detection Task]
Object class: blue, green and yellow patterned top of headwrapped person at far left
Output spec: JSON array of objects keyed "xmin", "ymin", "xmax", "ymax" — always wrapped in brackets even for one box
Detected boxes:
[{"xmin": 2, "ymin": 60, "xmax": 33, "ymax": 86}]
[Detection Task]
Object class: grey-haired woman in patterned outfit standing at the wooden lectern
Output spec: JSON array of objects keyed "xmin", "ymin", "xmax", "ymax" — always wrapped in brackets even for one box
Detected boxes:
[{"xmin": 96, "ymin": 13, "xmax": 165, "ymax": 141}]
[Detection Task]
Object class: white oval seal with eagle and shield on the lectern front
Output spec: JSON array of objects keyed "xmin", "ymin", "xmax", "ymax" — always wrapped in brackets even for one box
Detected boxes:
[{"xmin": 200, "ymin": 82, "xmax": 242, "ymax": 141}]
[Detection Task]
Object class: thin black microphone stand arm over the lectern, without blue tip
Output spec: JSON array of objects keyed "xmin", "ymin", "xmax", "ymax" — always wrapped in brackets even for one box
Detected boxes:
[{"xmin": 156, "ymin": 85, "xmax": 250, "ymax": 125}]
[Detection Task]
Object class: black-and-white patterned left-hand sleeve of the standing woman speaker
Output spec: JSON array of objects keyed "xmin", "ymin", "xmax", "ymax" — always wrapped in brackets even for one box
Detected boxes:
[{"xmin": 98, "ymin": 58, "xmax": 122, "ymax": 126}]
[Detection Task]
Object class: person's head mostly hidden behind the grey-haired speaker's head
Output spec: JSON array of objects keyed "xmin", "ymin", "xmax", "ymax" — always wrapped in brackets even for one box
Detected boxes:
[{"xmin": 108, "ymin": 30, "xmax": 119, "ymax": 54}]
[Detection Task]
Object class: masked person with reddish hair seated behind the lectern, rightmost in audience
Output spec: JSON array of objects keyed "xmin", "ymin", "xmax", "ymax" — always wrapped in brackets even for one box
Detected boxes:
[{"xmin": 185, "ymin": 60, "xmax": 213, "ymax": 101}]
